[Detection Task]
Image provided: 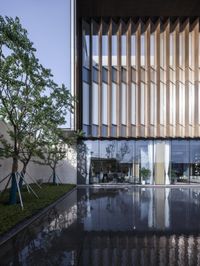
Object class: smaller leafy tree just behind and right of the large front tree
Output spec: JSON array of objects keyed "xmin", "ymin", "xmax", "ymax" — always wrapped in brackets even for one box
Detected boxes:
[{"xmin": 19, "ymin": 92, "xmax": 71, "ymax": 189}]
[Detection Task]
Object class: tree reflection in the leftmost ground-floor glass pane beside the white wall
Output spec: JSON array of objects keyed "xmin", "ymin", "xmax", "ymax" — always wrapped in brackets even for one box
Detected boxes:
[{"xmin": 77, "ymin": 141, "xmax": 88, "ymax": 184}]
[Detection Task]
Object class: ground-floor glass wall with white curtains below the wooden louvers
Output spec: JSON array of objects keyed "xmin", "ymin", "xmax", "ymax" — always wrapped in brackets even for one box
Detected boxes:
[{"xmin": 77, "ymin": 140, "xmax": 200, "ymax": 185}]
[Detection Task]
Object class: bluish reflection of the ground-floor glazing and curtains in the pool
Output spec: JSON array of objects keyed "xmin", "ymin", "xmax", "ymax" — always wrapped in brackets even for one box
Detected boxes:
[{"xmin": 78, "ymin": 188, "xmax": 200, "ymax": 233}]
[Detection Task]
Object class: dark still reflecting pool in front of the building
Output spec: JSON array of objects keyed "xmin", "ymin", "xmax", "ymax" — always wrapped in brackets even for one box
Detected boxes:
[{"xmin": 0, "ymin": 187, "xmax": 200, "ymax": 266}]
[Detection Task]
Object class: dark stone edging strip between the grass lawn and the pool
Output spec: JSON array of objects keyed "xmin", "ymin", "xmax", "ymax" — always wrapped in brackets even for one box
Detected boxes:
[{"xmin": 0, "ymin": 186, "xmax": 77, "ymax": 246}]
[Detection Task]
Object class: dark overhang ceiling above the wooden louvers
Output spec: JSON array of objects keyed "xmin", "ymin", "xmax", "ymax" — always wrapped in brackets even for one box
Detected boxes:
[{"xmin": 77, "ymin": 0, "xmax": 200, "ymax": 17}]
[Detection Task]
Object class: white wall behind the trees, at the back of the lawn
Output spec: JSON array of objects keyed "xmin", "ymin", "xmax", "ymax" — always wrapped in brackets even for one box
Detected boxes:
[{"xmin": 0, "ymin": 121, "xmax": 77, "ymax": 191}]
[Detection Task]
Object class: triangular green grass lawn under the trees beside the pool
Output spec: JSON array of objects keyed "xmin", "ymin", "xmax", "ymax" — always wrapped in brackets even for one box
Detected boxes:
[{"xmin": 0, "ymin": 184, "xmax": 74, "ymax": 236}]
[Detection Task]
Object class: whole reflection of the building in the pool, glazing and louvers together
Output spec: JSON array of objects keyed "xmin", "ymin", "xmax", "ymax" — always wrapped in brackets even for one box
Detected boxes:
[{"xmin": 76, "ymin": 188, "xmax": 200, "ymax": 266}]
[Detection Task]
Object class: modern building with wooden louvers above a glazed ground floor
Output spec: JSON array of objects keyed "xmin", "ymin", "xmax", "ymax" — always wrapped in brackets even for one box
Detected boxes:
[{"xmin": 72, "ymin": 0, "xmax": 200, "ymax": 185}]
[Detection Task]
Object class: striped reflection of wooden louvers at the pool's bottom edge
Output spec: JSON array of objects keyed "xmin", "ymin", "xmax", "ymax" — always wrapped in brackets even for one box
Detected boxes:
[{"xmin": 80, "ymin": 233, "xmax": 200, "ymax": 266}]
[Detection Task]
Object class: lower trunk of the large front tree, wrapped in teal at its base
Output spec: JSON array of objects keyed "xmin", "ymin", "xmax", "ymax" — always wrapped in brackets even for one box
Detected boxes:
[{"xmin": 9, "ymin": 158, "xmax": 18, "ymax": 205}]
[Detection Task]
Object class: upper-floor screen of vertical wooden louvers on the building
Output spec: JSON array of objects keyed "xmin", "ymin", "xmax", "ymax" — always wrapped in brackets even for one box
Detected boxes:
[{"xmin": 80, "ymin": 18, "xmax": 200, "ymax": 138}]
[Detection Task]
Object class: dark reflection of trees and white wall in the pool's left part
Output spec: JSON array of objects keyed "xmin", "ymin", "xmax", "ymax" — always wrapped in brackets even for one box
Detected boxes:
[{"xmin": 0, "ymin": 204, "xmax": 77, "ymax": 266}]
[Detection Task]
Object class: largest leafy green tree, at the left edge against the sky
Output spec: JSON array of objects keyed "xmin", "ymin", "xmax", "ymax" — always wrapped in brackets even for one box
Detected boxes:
[{"xmin": 0, "ymin": 16, "xmax": 74, "ymax": 204}]
